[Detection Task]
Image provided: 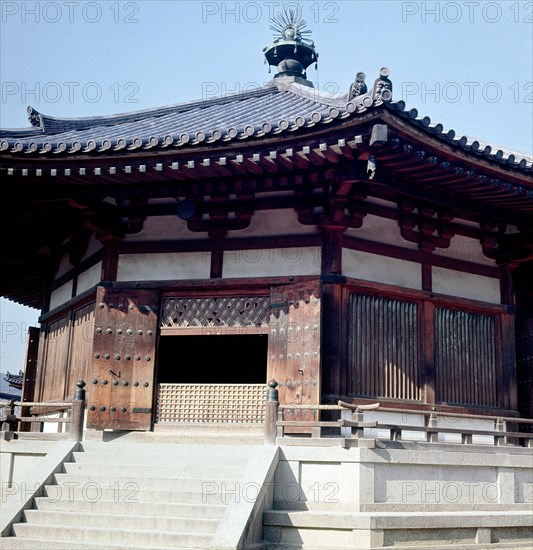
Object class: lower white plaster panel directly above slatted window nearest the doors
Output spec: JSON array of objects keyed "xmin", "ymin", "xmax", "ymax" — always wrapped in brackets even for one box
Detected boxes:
[{"xmin": 342, "ymin": 248, "xmax": 422, "ymax": 290}]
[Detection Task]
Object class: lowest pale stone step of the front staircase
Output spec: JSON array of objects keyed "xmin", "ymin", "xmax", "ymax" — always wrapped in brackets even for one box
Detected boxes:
[{"xmin": 13, "ymin": 523, "xmax": 212, "ymax": 549}]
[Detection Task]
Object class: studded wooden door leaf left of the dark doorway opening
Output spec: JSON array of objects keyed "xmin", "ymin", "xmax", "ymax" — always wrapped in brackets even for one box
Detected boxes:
[{"xmin": 87, "ymin": 287, "xmax": 159, "ymax": 430}]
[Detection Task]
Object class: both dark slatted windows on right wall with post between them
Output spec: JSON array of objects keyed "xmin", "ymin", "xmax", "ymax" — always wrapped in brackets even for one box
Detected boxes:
[{"xmin": 346, "ymin": 291, "xmax": 514, "ymax": 410}]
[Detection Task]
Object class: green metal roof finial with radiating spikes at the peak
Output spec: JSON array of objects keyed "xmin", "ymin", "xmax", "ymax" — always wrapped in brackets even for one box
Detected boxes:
[{"xmin": 263, "ymin": 8, "xmax": 318, "ymax": 86}]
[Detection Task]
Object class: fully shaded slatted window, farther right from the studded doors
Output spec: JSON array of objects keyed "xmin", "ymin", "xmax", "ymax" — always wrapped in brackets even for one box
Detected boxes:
[{"xmin": 435, "ymin": 307, "xmax": 498, "ymax": 407}]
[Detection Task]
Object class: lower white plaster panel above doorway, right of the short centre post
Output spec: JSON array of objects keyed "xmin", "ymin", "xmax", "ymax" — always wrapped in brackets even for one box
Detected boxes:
[{"xmin": 222, "ymin": 247, "xmax": 321, "ymax": 279}]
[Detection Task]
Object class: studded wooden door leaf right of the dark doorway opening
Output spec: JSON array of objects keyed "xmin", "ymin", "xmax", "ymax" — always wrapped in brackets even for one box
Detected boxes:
[{"xmin": 268, "ymin": 280, "xmax": 321, "ymax": 420}]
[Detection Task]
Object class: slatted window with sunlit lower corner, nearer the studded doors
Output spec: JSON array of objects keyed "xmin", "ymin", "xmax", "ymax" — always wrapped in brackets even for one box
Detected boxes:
[{"xmin": 350, "ymin": 294, "xmax": 421, "ymax": 400}]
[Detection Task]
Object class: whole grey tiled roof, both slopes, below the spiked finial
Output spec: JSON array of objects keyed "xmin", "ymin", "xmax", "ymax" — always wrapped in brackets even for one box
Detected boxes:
[{"xmin": 0, "ymin": 79, "xmax": 533, "ymax": 172}]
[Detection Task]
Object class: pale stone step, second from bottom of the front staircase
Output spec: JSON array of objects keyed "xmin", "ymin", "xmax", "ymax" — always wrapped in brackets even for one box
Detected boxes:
[{"xmin": 24, "ymin": 510, "xmax": 220, "ymax": 534}]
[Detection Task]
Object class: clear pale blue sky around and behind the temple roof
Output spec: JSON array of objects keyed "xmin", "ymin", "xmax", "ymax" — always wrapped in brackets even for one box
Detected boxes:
[{"xmin": 0, "ymin": 0, "xmax": 533, "ymax": 371}]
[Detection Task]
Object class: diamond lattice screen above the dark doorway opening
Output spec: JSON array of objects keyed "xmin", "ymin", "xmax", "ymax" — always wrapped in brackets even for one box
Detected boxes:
[{"xmin": 161, "ymin": 296, "xmax": 269, "ymax": 328}]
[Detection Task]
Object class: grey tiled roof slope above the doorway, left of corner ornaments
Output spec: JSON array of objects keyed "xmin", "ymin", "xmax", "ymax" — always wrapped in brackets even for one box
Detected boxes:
[{"xmin": 0, "ymin": 83, "xmax": 382, "ymax": 158}]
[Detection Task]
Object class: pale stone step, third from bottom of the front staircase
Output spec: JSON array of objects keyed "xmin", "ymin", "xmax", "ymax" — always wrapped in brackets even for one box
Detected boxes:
[{"xmin": 34, "ymin": 495, "xmax": 226, "ymax": 520}]
